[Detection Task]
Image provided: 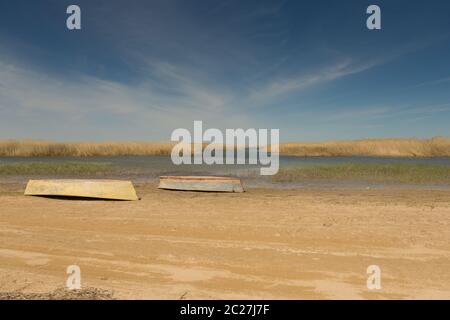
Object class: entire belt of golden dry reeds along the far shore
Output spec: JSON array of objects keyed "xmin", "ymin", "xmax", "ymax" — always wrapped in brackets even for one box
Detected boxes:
[{"xmin": 0, "ymin": 137, "xmax": 450, "ymax": 157}]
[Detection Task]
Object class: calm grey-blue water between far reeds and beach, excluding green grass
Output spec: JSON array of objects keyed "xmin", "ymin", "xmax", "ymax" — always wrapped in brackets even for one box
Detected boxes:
[{"xmin": 0, "ymin": 156, "xmax": 450, "ymax": 187}]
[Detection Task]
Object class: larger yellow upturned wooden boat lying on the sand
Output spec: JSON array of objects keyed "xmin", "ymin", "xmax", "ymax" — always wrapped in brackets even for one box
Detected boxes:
[{"xmin": 25, "ymin": 179, "xmax": 139, "ymax": 201}]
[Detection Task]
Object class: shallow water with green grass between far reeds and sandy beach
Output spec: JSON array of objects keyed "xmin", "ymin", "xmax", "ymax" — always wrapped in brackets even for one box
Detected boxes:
[{"xmin": 0, "ymin": 156, "xmax": 450, "ymax": 188}]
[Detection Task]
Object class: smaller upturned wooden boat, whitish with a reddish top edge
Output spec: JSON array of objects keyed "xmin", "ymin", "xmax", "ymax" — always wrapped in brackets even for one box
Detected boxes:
[{"xmin": 158, "ymin": 176, "xmax": 244, "ymax": 192}]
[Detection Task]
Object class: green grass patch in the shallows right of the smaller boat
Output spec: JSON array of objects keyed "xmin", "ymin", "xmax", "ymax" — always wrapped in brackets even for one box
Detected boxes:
[{"xmin": 273, "ymin": 163, "xmax": 450, "ymax": 184}]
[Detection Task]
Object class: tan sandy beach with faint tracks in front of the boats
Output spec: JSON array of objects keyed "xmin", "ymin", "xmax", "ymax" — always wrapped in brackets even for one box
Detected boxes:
[{"xmin": 0, "ymin": 184, "xmax": 450, "ymax": 299}]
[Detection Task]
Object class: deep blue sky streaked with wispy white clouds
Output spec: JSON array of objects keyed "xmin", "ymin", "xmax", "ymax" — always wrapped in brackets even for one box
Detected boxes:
[{"xmin": 0, "ymin": 0, "xmax": 450, "ymax": 141}]
